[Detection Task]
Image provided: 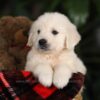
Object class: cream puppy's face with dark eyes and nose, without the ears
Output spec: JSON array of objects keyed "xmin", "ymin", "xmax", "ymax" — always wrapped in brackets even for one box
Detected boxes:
[{"xmin": 33, "ymin": 20, "xmax": 65, "ymax": 52}]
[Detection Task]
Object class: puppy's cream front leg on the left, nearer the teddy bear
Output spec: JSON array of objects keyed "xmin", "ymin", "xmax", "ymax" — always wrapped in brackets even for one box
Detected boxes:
[{"xmin": 33, "ymin": 64, "xmax": 53, "ymax": 87}]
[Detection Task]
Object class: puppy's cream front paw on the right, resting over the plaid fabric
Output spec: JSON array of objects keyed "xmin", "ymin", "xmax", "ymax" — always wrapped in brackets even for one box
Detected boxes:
[{"xmin": 53, "ymin": 66, "xmax": 71, "ymax": 89}]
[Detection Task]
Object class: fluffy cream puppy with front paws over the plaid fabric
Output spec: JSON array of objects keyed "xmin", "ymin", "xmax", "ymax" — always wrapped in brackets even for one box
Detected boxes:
[{"xmin": 25, "ymin": 12, "xmax": 86, "ymax": 88}]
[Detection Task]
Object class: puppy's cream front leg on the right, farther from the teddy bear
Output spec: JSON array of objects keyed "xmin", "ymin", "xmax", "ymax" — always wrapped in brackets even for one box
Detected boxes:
[{"xmin": 53, "ymin": 64, "xmax": 72, "ymax": 88}]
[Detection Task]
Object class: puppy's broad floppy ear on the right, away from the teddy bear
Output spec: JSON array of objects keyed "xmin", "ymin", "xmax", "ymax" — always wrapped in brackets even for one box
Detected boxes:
[{"xmin": 65, "ymin": 24, "xmax": 81, "ymax": 49}]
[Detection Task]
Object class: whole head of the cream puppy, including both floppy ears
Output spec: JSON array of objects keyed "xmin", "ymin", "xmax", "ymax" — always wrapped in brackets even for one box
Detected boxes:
[{"xmin": 27, "ymin": 12, "xmax": 80, "ymax": 52}]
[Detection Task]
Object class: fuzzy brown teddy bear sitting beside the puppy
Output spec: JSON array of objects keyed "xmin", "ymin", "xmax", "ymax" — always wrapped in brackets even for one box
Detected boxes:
[{"xmin": 0, "ymin": 16, "xmax": 31, "ymax": 69}]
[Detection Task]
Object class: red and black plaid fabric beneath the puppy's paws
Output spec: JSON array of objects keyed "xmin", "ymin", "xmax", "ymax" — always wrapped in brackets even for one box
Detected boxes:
[{"xmin": 0, "ymin": 70, "xmax": 84, "ymax": 100}]
